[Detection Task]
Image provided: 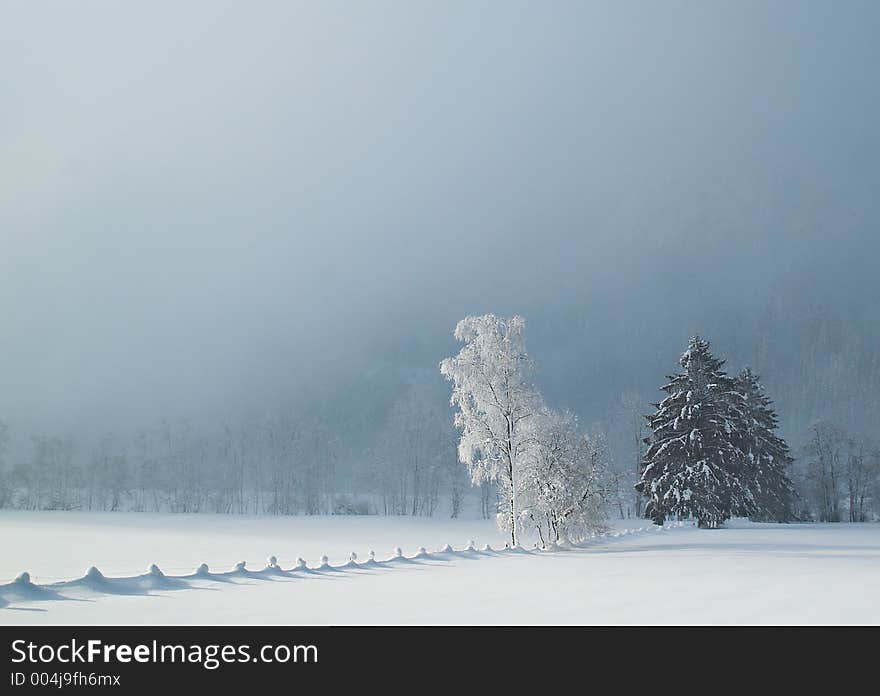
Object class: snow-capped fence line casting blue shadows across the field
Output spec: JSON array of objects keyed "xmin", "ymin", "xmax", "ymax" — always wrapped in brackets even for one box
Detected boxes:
[{"xmin": 0, "ymin": 522, "xmax": 693, "ymax": 607}]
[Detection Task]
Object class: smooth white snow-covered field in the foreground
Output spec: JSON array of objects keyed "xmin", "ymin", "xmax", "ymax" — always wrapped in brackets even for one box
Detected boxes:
[{"xmin": 0, "ymin": 511, "xmax": 880, "ymax": 624}]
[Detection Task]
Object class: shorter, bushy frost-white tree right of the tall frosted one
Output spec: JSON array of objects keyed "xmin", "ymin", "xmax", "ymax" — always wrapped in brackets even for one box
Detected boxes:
[{"xmin": 522, "ymin": 409, "xmax": 608, "ymax": 545}]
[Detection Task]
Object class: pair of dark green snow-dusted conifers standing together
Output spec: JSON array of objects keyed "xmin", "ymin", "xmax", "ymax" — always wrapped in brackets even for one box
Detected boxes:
[{"xmin": 636, "ymin": 336, "xmax": 797, "ymax": 527}]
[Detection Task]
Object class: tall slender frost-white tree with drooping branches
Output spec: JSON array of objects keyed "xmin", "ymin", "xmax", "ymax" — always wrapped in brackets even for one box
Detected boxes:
[{"xmin": 440, "ymin": 314, "xmax": 543, "ymax": 546}]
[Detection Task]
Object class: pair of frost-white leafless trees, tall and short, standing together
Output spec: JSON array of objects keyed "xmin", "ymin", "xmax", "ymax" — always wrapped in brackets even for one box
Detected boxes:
[{"xmin": 440, "ymin": 314, "xmax": 605, "ymax": 547}]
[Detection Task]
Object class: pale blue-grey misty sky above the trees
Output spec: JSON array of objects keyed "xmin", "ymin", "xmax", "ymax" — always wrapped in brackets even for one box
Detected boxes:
[{"xmin": 0, "ymin": 0, "xmax": 880, "ymax": 440}]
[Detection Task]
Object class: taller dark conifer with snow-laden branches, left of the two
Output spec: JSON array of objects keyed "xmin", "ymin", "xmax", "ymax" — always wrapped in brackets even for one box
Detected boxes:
[{"xmin": 636, "ymin": 336, "xmax": 751, "ymax": 527}]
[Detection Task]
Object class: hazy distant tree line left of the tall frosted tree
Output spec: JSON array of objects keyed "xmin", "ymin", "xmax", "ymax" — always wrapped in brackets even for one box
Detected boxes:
[{"xmin": 0, "ymin": 400, "xmax": 474, "ymax": 517}]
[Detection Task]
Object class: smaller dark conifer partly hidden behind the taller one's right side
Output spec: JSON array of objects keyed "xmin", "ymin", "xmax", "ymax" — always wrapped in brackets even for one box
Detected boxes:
[{"xmin": 736, "ymin": 368, "xmax": 796, "ymax": 522}]
